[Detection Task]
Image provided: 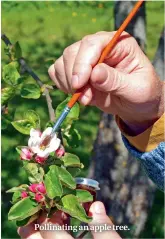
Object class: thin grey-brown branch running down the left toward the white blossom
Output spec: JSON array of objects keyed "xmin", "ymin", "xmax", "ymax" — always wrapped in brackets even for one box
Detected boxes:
[{"xmin": 1, "ymin": 34, "xmax": 55, "ymax": 122}]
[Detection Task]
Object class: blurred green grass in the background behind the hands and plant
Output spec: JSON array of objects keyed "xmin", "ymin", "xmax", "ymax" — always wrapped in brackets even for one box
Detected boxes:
[{"xmin": 2, "ymin": 1, "xmax": 164, "ymax": 238}]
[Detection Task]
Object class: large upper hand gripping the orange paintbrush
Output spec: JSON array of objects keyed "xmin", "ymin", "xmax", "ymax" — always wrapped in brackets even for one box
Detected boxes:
[{"xmin": 49, "ymin": 32, "xmax": 164, "ymax": 134}]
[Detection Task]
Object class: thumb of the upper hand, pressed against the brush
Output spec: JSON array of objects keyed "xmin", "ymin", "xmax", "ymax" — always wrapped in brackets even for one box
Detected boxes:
[{"xmin": 90, "ymin": 63, "xmax": 129, "ymax": 94}]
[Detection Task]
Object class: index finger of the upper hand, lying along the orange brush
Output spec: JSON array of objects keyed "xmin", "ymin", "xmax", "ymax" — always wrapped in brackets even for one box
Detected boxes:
[{"xmin": 71, "ymin": 32, "xmax": 114, "ymax": 89}]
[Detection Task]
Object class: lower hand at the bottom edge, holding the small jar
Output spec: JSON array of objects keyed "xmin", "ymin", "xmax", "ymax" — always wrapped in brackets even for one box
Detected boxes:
[{"xmin": 18, "ymin": 202, "xmax": 121, "ymax": 239}]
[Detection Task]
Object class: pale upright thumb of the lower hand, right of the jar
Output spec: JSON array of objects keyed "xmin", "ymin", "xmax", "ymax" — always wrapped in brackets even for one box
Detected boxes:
[{"xmin": 89, "ymin": 202, "xmax": 121, "ymax": 239}]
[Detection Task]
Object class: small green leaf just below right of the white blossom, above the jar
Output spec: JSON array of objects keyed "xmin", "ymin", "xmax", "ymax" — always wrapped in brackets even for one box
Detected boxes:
[{"xmin": 61, "ymin": 153, "xmax": 82, "ymax": 168}]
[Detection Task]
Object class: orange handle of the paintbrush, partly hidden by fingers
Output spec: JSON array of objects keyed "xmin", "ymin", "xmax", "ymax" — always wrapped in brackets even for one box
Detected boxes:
[{"xmin": 67, "ymin": 0, "xmax": 144, "ymax": 108}]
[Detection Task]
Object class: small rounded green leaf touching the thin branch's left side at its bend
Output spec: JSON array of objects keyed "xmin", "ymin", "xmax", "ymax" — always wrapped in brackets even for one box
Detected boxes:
[{"xmin": 21, "ymin": 84, "xmax": 41, "ymax": 99}]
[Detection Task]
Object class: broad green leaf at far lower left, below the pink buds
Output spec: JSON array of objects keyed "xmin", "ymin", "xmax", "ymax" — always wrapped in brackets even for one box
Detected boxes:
[{"xmin": 8, "ymin": 197, "xmax": 41, "ymax": 221}]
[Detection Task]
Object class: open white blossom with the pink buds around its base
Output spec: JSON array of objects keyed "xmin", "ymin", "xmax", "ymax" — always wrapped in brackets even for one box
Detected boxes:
[{"xmin": 20, "ymin": 127, "xmax": 65, "ymax": 164}]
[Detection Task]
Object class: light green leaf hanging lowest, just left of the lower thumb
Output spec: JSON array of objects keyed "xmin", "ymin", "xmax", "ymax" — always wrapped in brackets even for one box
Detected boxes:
[{"xmin": 56, "ymin": 194, "xmax": 92, "ymax": 223}]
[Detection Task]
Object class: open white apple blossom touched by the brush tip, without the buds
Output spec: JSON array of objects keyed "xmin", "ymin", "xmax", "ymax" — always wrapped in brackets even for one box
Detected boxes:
[{"xmin": 28, "ymin": 127, "xmax": 61, "ymax": 158}]
